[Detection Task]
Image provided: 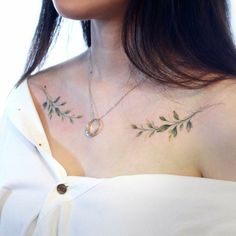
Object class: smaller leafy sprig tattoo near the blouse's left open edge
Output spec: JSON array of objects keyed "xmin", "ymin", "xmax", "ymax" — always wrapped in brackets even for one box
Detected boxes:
[{"xmin": 40, "ymin": 86, "xmax": 83, "ymax": 124}]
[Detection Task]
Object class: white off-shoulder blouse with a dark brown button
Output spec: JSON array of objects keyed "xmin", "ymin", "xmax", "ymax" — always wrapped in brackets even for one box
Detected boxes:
[{"xmin": 0, "ymin": 80, "xmax": 236, "ymax": 236}]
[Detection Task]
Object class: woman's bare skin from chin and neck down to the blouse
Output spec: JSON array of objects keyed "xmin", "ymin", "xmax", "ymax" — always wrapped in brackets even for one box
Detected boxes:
[{"xmin": 25, "ymin": 0, "xmax": 236, "ymax": 179}]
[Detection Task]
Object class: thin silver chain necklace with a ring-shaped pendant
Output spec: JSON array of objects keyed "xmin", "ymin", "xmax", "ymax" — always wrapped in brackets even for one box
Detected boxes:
[{"xmin": 85, "ymin": 48, "xmax": 146, "ymax": 137}]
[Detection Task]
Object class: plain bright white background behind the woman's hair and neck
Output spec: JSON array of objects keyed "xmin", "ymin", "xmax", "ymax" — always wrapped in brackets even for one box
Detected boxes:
[{"xmin": 0, "ymin": 0, "xmax": 236, "ymax": 115}]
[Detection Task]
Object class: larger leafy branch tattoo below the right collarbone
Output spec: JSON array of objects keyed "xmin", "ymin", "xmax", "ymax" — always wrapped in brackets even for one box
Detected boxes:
[{"xmin": 131, "ymin": 104, "xmax": 223, "ymax": 141}]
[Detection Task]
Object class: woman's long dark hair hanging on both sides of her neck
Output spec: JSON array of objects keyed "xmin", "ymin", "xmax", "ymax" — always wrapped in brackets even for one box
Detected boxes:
[{"xmin": 15, "ymin": 0, "xmax": 236, "ymax": 89}]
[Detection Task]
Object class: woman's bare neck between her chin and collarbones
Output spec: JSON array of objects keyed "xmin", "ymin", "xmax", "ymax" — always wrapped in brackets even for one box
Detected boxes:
[{"xmin": 88, "ymin": 19, "xmax": 140, "ymax": 86}]
